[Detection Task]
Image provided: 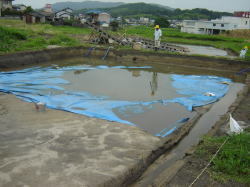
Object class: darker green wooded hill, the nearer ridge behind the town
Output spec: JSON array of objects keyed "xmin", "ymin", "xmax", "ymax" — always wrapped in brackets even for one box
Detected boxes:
[{"xmin": 69, "ymin": 1, "xmax": 232, "ymax": 20}]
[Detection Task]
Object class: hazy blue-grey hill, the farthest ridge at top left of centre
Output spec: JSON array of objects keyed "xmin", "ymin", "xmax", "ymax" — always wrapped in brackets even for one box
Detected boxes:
[{"xmin": 52, "ymin": 1, "xmax": 124, "ymax": 10}]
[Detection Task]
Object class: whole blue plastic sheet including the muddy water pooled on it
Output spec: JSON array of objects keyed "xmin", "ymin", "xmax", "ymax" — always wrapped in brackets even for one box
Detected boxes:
[{"xmin": 0, "ymin": 60, "xmax": 238, "ymax": 137}]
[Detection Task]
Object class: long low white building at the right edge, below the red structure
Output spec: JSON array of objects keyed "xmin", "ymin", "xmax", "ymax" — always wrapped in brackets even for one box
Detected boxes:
[{"xmin": 181, "ymin": 16, "xmax": 250, "ymax": 34}]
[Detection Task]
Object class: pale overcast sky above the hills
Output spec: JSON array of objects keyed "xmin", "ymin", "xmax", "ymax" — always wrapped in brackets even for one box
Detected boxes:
[{"xmin": 14, "ymin": 0, "xmax": 250, "ymax": 12}]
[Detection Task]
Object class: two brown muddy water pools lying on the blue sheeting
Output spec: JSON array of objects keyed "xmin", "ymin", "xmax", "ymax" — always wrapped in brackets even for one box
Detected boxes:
[{"xmin": 63, "ymin": 69, "xmax": 195, "ymax": 135}]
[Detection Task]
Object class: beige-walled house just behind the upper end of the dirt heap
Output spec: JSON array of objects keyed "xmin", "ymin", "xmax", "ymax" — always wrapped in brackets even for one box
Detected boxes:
[{"xmin": 86, "ymin": 10, "xmax": 111, "ymax": 26}]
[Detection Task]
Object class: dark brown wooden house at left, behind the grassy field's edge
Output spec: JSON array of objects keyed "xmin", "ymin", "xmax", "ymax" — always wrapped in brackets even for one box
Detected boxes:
[{"xmin": 24, "ymin": 11, "xmax": 54, "ymax": 23}]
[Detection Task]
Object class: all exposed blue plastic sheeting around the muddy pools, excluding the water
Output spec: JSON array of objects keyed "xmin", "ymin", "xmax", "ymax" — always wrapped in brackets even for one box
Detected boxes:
[{"xmin": 0, "ymin": 65, "xmax": 231, "ymax": 137}]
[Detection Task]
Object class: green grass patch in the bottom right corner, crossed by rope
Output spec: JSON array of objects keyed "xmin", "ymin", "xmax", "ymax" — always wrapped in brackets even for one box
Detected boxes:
[{"xmin": 196, "ymin": 132, "xmax": 250, "ymax": 185}]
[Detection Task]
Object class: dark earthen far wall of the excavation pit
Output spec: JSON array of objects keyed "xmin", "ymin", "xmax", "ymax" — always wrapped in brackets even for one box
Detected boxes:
[{"xmin": 0, "ymin": 47, "xmax": 250, "ymax": 71}]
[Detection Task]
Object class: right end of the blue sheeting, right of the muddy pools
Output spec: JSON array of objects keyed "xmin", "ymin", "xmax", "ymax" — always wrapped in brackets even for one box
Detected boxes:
[{"xmin": 164, "ymin": 75, "xmax": 231, "ymax": 111}]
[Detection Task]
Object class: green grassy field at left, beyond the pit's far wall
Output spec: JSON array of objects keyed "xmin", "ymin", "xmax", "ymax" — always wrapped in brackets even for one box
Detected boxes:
[{"xmin": 0, "ymin": 20, "xmax": 91, "ymax": 54}]
